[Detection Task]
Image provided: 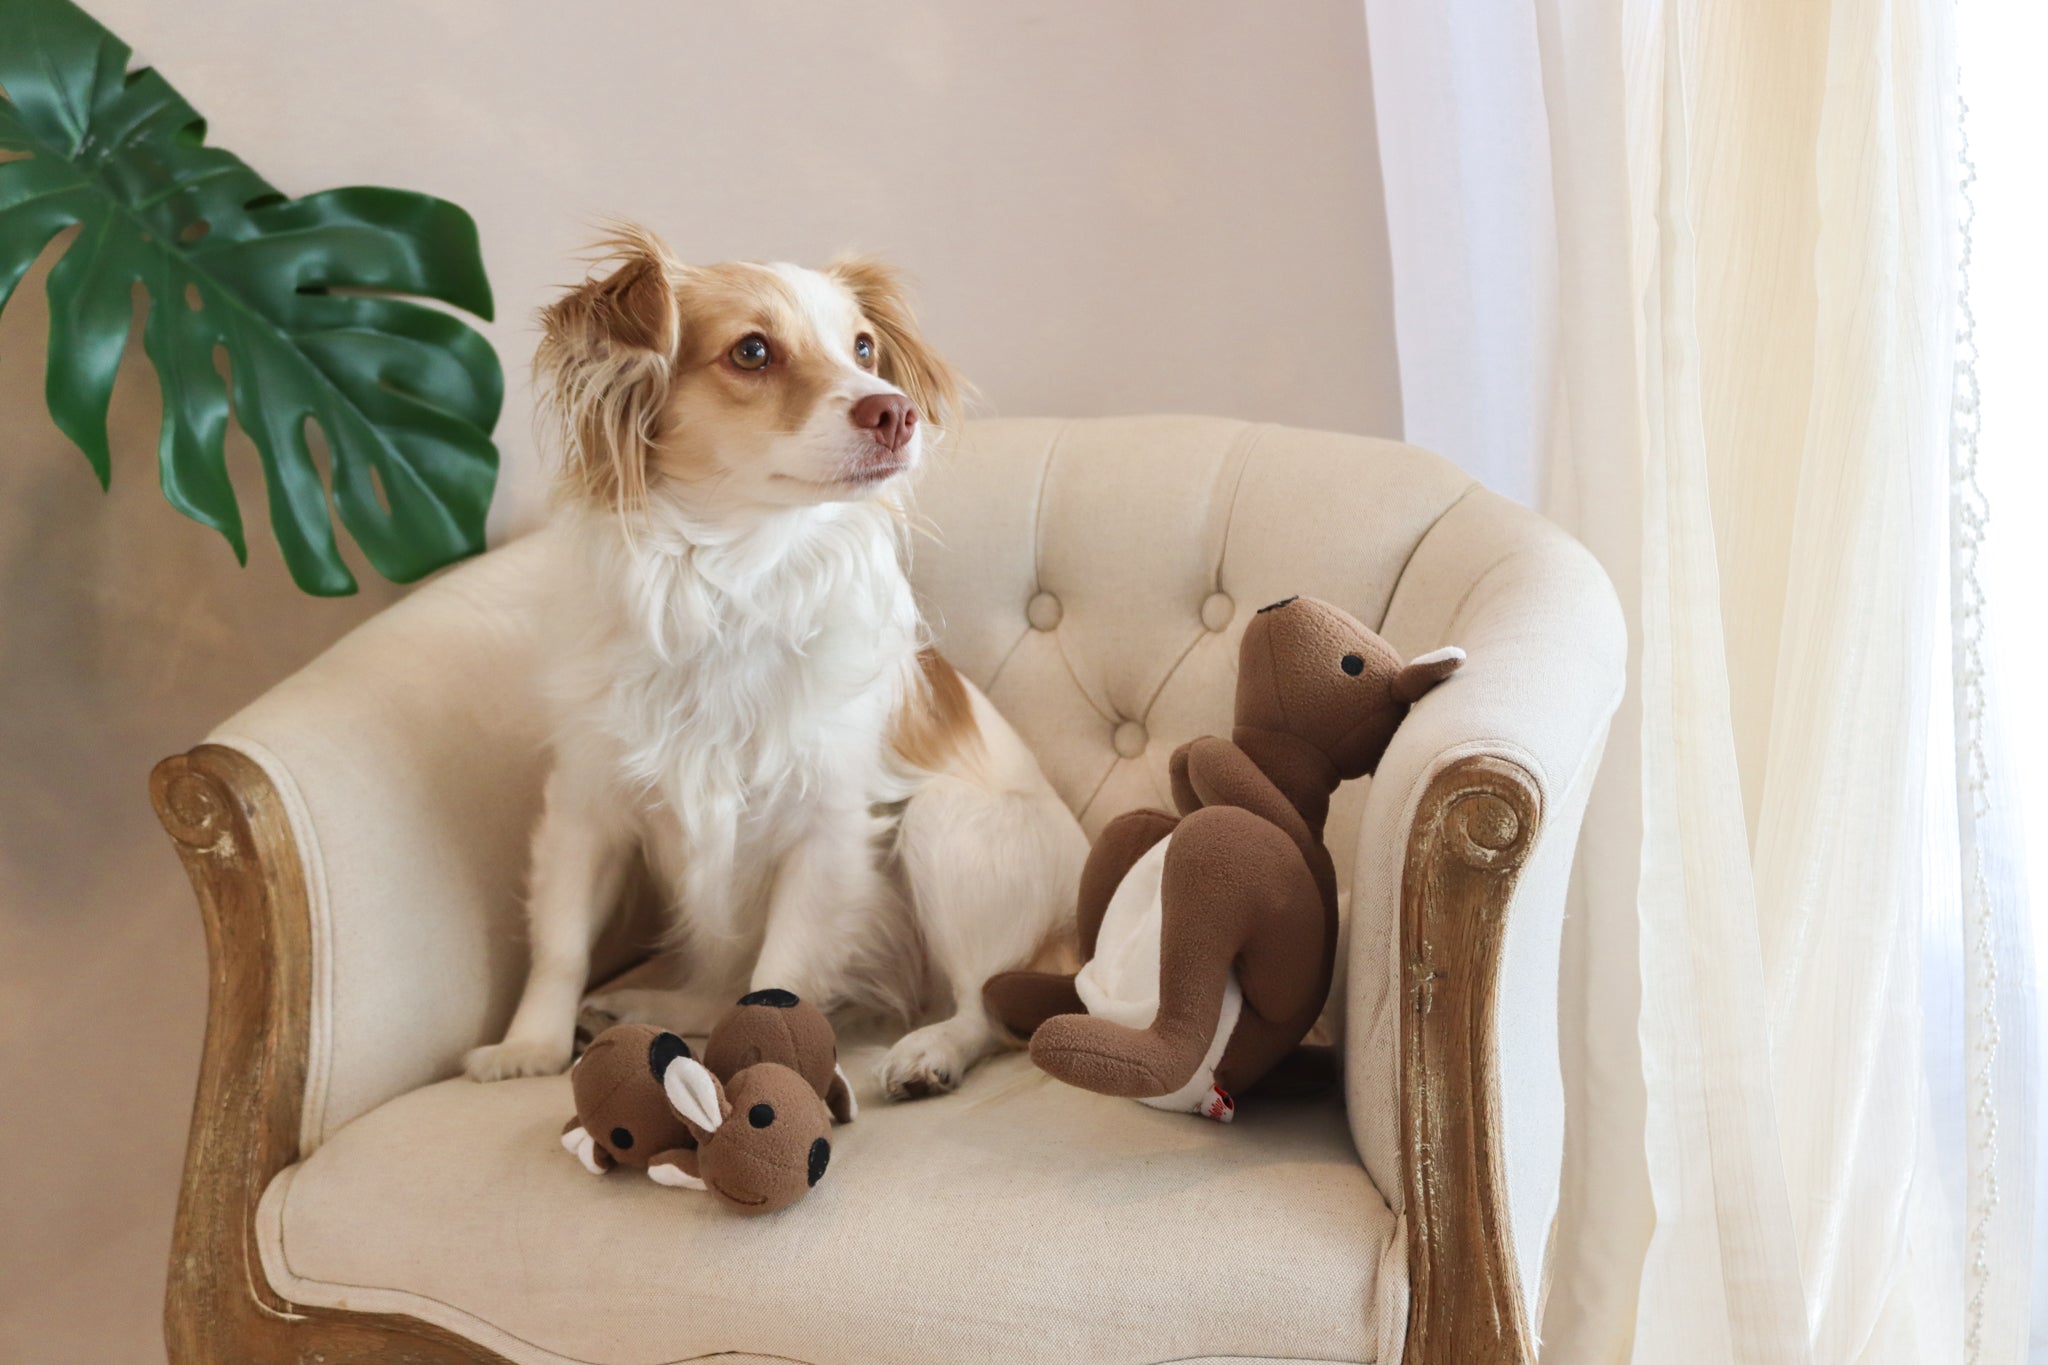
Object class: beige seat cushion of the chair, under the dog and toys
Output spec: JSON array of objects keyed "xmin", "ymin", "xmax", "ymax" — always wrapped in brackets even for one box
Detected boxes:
[{"xmin": 258, "ymin": 1054, "xmax": 1405, "ymax": 1365}]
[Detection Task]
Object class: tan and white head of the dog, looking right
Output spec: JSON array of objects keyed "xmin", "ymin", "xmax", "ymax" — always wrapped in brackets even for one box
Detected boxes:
[{"xmin": 535, "ymin": 229, "xmax": 961, "ymax": 512}]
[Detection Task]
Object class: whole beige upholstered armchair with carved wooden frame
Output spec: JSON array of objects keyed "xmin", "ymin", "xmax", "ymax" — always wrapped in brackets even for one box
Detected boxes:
[{"xmin": 154, "ymin": 417, "xmax": 1624, "ymax": 1363}]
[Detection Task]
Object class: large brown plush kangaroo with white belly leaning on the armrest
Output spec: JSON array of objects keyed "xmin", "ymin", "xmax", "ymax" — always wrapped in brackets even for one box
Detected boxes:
[{"xmin": 983, "ymin": 598, "xmax": 1464, "ymax": 1119}]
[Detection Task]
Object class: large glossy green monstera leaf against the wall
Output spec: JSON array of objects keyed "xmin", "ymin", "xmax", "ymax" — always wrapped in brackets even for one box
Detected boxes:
[{"xmin": 0, "ymin": 0, "xmax": 504, "ymax": 596}]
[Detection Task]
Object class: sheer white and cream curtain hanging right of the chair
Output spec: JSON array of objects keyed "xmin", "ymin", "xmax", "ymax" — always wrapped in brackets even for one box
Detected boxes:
[{"xmin": 1366, "ymin": 0, "xmax": 2034, "ymax": 1365}]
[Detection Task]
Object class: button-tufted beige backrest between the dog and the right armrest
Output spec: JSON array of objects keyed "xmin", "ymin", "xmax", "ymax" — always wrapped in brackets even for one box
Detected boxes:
[{"xmin": 911, "ymin": 417, "xmax": 1475, "ymax": 886}]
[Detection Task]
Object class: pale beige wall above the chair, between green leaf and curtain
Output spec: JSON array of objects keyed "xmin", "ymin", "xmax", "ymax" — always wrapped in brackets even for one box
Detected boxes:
[{"xmin": 75, "ymin": 0, "xmax": 1401, "ymax": 526}]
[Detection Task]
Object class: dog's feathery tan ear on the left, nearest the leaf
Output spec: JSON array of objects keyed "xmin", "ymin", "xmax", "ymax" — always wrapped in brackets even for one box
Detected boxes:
[{"xmin": 532, "ymin": 225, "xmax": 682, "ymax": 512}]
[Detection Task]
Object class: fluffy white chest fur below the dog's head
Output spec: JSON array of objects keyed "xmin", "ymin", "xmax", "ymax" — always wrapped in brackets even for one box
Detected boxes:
[{"xmin": 553, "ymin": 505, "xmax": 918, "ymax": 933}]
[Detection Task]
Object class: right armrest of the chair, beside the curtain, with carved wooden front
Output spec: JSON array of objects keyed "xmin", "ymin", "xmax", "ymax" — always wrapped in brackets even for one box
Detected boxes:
[{"xmin": 1346, "ymin": 489, "xmax": 1626, "ymax": 1363}]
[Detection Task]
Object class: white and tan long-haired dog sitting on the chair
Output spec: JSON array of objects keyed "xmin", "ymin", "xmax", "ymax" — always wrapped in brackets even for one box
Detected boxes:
[{"xmin": 465, "ymin": 227, "xmax": 1087, "ymax": 1099}]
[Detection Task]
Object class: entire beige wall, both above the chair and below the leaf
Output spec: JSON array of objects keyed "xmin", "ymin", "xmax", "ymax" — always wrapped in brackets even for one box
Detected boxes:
[{"xmin": 0, "ymin": 0, "xmax": 1399, "ymax": 1365}]
